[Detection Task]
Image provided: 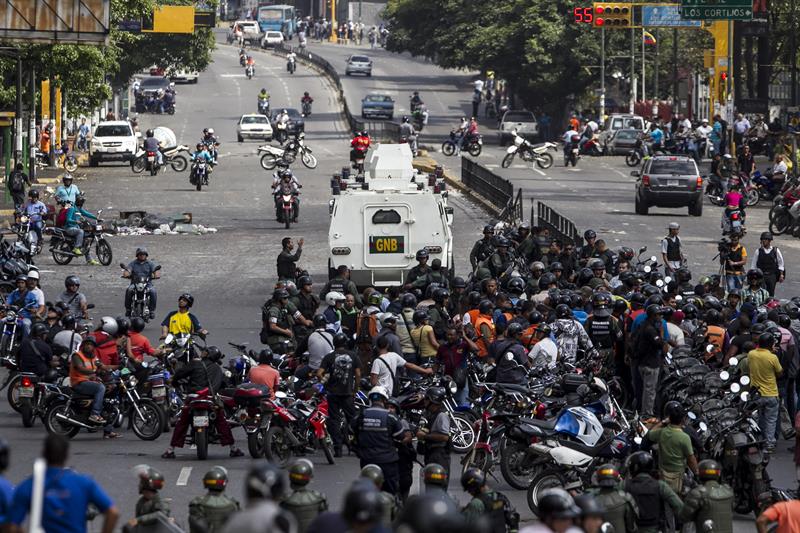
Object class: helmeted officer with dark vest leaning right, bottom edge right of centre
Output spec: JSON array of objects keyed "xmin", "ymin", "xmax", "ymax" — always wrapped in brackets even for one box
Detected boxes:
[{"xmin": 461, "ymin": 467, "xmax": 519, "ymax": 533}]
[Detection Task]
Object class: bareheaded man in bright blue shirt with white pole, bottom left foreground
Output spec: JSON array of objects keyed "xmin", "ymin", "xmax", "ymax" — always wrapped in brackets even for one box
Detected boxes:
[{"xmin": 8, "ymin": 435, "xmax": 119, "ymax": 533}]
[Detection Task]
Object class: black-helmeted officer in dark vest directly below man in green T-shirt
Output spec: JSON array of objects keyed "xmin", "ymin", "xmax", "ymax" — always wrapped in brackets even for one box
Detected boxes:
[{"xmin": 625, "ymin": 452, "xmax": 683, "ymax": 533}]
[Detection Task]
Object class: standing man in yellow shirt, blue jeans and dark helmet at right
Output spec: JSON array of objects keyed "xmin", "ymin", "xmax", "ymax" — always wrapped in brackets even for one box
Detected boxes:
[{"xmin": 747, "ymin": 333, "xmax": 783, "ymax": 453}]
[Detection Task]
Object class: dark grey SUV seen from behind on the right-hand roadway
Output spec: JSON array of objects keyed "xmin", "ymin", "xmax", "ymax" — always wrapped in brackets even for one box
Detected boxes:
[{"xmin": 631, "ymin": 155, "xmax": 703, "ymax": 217}]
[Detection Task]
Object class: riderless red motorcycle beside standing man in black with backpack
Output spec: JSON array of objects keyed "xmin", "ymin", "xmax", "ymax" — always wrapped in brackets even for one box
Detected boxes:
[{"xmin": 264, "ymin": 388, "xmax": 335, "ymax": 468}]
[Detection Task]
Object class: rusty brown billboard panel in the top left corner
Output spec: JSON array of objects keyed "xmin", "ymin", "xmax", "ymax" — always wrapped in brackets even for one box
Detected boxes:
[{"xmin": 0, "ymin": 0, "xmax": 111, "ymax": 44}]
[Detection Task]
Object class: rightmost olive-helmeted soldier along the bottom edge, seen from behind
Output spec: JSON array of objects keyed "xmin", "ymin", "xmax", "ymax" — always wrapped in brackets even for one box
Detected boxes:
[{"xmin": 681, "ymin": 459, "xmax": 734, "ymax": 533}]
